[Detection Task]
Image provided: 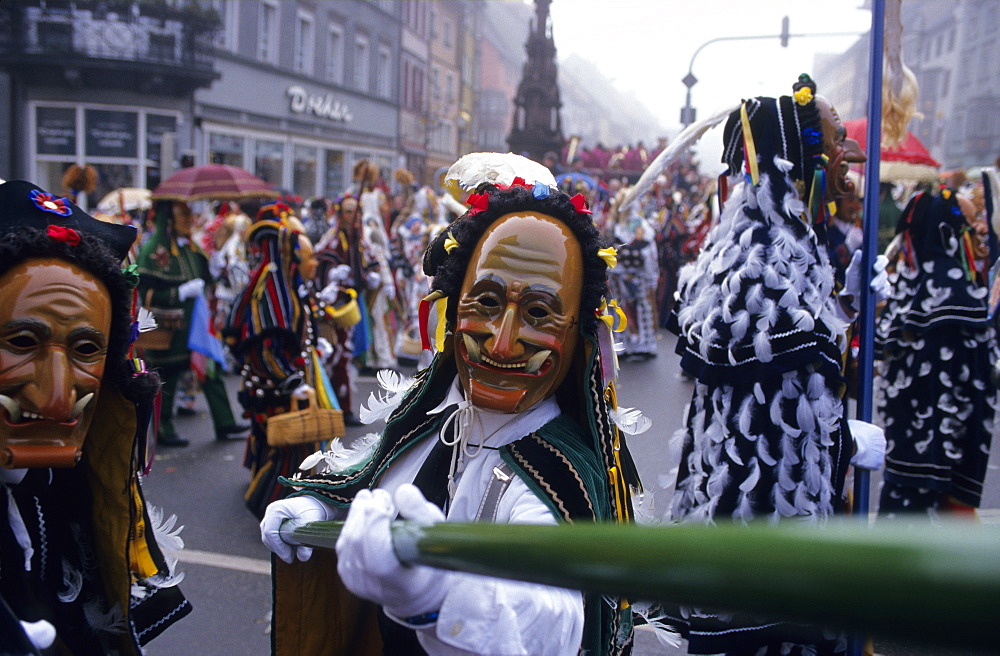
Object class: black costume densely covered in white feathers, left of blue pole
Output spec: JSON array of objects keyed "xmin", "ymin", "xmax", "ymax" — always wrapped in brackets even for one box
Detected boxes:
[{"xmin": 670, "ymin": 91, "xmax": 853, "ymax": 654}]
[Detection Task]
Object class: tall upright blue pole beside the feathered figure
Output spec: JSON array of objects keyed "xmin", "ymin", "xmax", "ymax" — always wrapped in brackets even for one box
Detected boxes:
[{"xmin": 848, "ymin": 0, "xmax": 885, "ymax": 656}]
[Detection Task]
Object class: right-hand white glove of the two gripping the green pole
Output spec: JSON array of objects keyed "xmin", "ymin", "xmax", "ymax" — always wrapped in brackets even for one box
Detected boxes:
[{"xmin": 337, "ymin": 484, "xmax": 448, "ymax": 618}]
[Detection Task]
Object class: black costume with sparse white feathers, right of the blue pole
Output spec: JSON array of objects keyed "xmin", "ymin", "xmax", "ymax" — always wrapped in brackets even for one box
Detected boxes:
[{"xmin": 875, "ymin": 190, "xmax": 1000, "ymax": 515}]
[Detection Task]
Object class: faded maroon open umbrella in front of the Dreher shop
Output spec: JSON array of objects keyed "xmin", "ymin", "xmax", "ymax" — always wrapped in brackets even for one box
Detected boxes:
[{"xmin": 152, "ymin": 164, "xmax": 279, "ymax": 201}]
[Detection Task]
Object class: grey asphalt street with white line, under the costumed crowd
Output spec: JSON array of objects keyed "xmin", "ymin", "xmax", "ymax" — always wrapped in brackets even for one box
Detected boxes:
[{"xmin": 144, "ymin": 334, "xmax": 1000, "ymax": 656}]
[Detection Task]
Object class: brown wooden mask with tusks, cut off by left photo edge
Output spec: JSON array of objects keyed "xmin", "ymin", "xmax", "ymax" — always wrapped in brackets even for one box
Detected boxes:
[{"xmin": 0, "ymin": 258, "xmax": 111, "ymax": 468}]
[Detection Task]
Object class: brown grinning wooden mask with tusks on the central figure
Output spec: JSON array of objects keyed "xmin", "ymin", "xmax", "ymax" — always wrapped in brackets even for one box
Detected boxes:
[{"xmin": 455, "ymin": 212, "xmax": 583, "ymax": 413}]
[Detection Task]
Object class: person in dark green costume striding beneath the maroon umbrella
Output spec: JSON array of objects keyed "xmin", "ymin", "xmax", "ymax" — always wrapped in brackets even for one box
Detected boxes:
[{"xmin": 137, "ymin": 200, "xmax": 249, "ymax": 447}]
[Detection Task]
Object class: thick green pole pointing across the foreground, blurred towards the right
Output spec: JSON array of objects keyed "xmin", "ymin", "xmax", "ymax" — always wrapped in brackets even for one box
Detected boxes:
[{"xmin": 283, "ymin": 522, "xmax": 1000, "ymax": 650}]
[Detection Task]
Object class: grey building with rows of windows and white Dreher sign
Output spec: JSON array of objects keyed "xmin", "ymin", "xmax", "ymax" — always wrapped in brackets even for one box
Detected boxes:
[{"xmin": 193, "ymin": 0, "xmax": 401, "ymax": 198}]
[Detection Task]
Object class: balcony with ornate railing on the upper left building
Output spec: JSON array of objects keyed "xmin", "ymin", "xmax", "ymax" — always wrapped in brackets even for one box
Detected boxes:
[{"xmin": 0, "ymin": 0, "xmax": 219, "ymax": 95}]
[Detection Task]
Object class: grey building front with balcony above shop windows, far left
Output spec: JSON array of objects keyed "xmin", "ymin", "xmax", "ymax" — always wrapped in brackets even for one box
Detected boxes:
[{"xmin": 0, "ymin": 0, "xmax": 218, "ymax": 202}]
